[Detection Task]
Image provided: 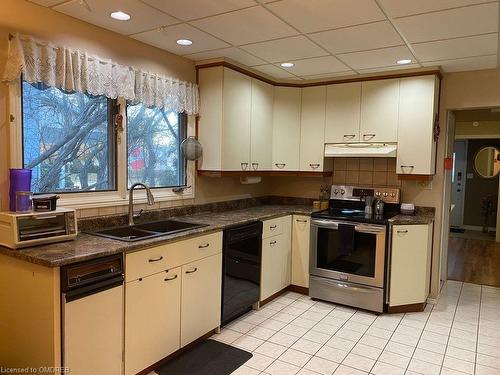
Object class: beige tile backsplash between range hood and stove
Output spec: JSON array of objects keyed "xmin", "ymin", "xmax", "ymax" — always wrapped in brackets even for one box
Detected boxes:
[{"xmin": 332, "ymin": 158, "xmax": 401, "ymax": 187}]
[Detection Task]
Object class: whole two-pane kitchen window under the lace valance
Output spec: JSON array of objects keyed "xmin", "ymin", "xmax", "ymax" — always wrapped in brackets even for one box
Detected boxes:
[{"xmin": 19, "ymin": 81, "xmax": 188, "ymax": 201}]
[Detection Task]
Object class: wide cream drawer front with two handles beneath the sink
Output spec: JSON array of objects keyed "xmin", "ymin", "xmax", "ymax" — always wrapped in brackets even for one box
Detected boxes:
[{"xmin": 125, "ymin": 232, "xmax": 222, "ymax": 282}]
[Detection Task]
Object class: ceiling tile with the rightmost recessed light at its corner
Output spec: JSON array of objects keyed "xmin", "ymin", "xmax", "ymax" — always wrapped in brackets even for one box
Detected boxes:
[{"xmin": 337, "ymin": 46, "xmax": 413, "ymax": 70}]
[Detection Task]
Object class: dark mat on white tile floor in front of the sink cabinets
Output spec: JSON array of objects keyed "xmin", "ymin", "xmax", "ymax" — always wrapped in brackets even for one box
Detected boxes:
[{"xmin": 155, "ymin": 340, "xmax": 252, "ymax": 375}]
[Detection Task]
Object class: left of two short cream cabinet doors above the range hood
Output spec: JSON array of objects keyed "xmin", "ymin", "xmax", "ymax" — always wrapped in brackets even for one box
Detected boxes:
[{"xmin": 325, "ymin": 82, "xmax": 361, "ymax": 143}]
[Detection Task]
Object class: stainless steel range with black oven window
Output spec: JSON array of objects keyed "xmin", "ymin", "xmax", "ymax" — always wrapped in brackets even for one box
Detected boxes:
[{"xmin": 309, "ymin": 185, "xmax": 400, "ymax": 312}]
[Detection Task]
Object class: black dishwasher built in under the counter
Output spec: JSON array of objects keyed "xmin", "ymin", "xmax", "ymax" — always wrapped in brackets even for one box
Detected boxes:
[{"xmin": 221, "ymin": 221, "xmax": 262, "ymax": 324}]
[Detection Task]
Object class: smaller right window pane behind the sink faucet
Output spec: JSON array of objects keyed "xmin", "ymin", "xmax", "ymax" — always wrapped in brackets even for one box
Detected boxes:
[{"xmin": 127, "ymin": 104, "xmax": 186, "ymax": 188}]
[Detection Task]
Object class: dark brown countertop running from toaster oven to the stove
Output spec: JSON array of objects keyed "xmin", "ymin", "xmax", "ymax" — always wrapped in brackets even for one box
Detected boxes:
[{"xmin": 0, "ymin": 205, "xmax": 313, "ymax": 267}]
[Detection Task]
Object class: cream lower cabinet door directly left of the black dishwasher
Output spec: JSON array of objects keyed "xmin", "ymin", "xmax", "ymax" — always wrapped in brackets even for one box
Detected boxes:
[{"xmin": 181, "ymin": 253, "xmax": 222, "ymax": 347}]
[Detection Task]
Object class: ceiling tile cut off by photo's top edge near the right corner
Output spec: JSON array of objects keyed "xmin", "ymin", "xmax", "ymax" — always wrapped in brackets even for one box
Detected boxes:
[{"xmin": 380, "ymin": 0, "xmax": 491, "ymax": 17}]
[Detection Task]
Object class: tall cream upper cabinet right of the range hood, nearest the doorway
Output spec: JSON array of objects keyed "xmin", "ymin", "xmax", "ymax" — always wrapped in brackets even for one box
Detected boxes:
[{"xmin": 396, "ymin": 75, "xmax": 439, "ymax": 175}]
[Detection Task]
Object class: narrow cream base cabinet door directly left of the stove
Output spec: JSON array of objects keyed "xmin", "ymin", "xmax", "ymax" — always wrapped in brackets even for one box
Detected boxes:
[{"xmin": 291, "ymin": 215, "xmax": 311, "ymax": 288}]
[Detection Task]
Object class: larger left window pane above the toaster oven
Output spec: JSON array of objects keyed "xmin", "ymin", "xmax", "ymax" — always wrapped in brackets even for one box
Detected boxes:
[{"xmin": 22, "ymin": 81, "xmax": 116, "ymax": 193}]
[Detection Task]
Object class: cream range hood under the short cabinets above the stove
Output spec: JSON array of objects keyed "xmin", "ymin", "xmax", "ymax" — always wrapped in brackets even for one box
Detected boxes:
[{"xmin": 325, "ymin": 143, "xmax": 397, "ymax": 158}]
